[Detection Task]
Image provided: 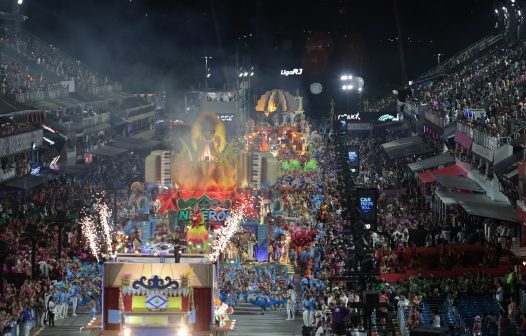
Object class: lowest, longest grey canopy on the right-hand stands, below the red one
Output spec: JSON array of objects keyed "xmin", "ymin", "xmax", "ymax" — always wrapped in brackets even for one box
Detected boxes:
[{"xmin": 436, "ymin": 191, "xmax": 517, "ymax": 222}]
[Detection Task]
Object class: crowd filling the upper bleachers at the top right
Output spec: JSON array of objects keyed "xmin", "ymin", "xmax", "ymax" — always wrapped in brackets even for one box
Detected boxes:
[{"xmin": 409, "ymin": 42, "xmax": 526, "ymax": 136}]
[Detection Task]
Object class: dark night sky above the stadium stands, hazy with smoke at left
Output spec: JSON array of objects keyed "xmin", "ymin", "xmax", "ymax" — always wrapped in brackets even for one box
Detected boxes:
[{"xmin": 11, "ymin": 0, "xmax": 495, "ymax": 115}]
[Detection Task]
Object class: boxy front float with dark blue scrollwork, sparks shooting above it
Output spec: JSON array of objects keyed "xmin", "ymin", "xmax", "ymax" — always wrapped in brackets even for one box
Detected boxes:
[{"xmin": 103, "ymin": 258, "xmax": 215, "ymax": 336}]
